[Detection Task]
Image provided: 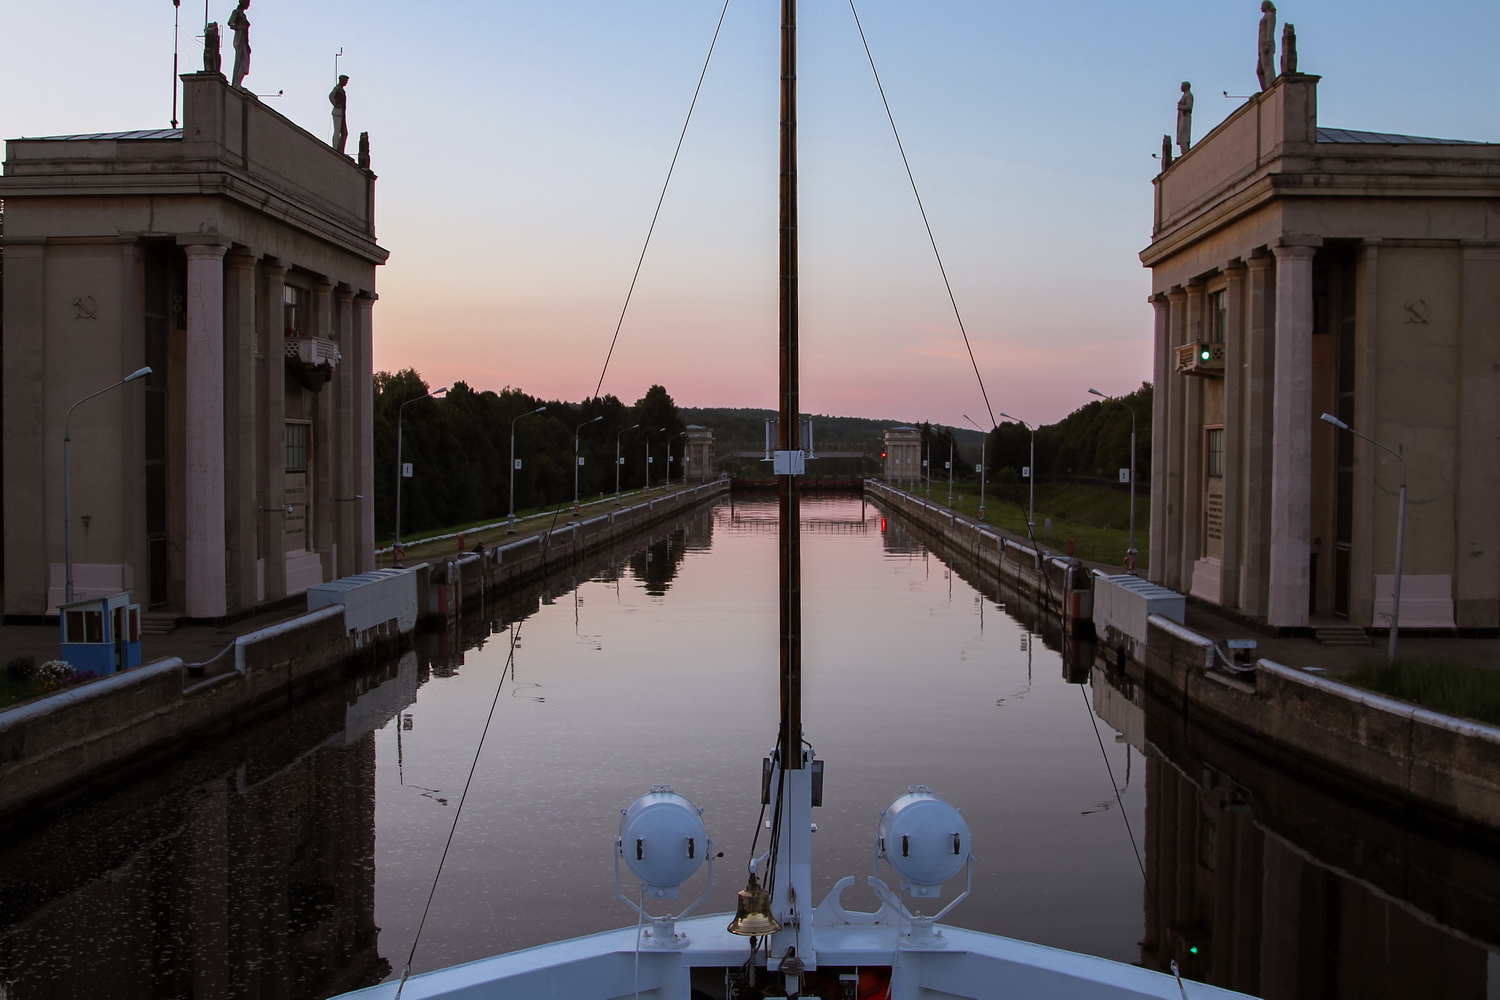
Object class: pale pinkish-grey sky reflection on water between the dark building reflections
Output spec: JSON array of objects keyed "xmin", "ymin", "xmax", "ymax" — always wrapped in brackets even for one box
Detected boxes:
[{"xmin": 377, "ymin": 496, "xmax": 1143, "ymax": 969}]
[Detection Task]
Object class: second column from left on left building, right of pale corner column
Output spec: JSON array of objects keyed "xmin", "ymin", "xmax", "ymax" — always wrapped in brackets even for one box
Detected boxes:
[{"xmin": 224, "ymin": 252, "xmax": 260, "ymax": 610}]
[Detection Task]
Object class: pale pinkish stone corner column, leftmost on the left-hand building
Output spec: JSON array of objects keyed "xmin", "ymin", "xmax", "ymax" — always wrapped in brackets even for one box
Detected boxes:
[{"xmin": 183, "ymin": 243, "xmax": 228, "ymax": 618}]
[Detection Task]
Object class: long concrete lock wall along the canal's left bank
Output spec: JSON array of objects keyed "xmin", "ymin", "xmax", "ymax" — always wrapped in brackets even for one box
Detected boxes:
[{"xmin": 0, "ymin": 483, "xmax": 729, "ymax": 829}]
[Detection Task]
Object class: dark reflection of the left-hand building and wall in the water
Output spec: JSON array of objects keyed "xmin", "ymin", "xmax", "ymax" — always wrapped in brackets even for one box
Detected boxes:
[{"xmin": 0, "ymin": 654, "xmax": 419, "ymax": 999}]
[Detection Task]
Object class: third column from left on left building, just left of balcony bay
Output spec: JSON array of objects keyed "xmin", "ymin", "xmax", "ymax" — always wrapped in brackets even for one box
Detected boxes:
[{"xmin": 255, "ymin": 261, "xmax": 287, "ymax": 601}]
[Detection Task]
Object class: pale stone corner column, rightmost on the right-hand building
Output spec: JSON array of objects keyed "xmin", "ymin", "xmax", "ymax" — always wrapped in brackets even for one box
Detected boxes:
[{"xmin": 1266, "ymin": 241, "xmax": 1317, "ymax": 628}]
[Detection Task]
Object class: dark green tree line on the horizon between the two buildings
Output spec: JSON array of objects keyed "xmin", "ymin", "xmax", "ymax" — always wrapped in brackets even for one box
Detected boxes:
[{"xmin": 374, "ymin": 369, "xmax": 1152, "ymax": 538}]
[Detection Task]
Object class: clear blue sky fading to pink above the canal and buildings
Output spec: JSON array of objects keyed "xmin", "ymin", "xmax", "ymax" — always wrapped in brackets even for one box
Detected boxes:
[{"xmin": 0, "ymin": 0, "xmax": 1500, "ymax": 426}]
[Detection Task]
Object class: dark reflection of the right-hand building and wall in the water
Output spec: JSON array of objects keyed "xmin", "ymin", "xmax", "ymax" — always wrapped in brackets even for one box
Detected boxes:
[{"xmin": 1094, "ymin": 659, "xmax": 1500, "ymax": 1000}]
